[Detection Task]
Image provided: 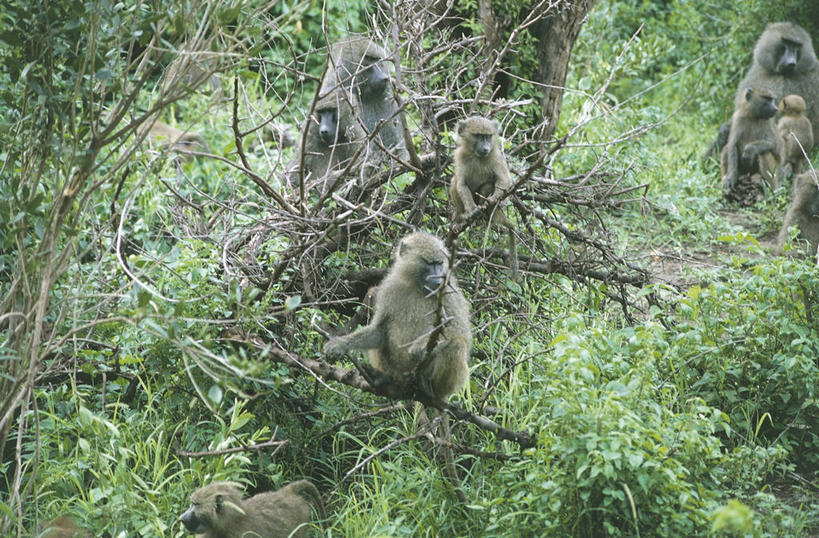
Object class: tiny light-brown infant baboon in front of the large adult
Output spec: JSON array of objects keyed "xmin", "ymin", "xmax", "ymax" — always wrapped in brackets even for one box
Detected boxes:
[{"xmin": 776, "ymin": 94, "xmax": 813, "ymax": 184}]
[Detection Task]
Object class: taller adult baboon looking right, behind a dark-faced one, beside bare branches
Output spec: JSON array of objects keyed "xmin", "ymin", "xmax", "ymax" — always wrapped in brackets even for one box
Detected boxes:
[{"xmin": 321, "ymin": 36, "xmax": 407, "ymax": 158}]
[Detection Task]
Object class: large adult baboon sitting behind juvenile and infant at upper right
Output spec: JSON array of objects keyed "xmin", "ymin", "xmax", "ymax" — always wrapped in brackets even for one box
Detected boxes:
[{"xmin": 705, "ymin": 22, "xmax": 819, "ymax": 157}]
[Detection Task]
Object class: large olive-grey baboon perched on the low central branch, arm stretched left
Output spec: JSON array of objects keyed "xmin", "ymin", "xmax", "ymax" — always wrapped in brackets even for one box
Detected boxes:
[{"xmin": 324, "ymin": 232, "xmax": 472, "ymax": 400}]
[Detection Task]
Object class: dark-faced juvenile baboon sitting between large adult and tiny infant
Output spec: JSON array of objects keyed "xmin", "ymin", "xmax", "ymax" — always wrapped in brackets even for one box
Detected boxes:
[{"xmin": 720, "ymin": 88, "xmax": 782, "ymax": 197}]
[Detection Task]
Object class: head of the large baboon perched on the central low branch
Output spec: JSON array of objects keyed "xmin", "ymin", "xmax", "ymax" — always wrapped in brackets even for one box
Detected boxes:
[{"xmin": 396, "ymin": 232, "xmax": 449, "ymax": 295}]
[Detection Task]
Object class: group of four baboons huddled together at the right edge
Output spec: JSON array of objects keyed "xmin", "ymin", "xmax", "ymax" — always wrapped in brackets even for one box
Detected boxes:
[{"xmin": 706, "ymin": 22, "xmax": 819, "ymax": 255}]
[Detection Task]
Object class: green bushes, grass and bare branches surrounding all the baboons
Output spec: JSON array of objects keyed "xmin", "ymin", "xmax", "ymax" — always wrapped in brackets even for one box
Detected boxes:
[{"xmin": 0, "ymin": 0, "xmax": 819, "ymax": 537}]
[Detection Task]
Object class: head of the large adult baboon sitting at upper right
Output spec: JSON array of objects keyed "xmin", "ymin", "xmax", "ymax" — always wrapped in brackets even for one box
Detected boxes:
[{"xmin": 754, "ymin": 22, "xmax": 816, "ymax": 77}]
